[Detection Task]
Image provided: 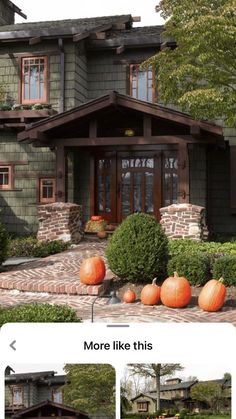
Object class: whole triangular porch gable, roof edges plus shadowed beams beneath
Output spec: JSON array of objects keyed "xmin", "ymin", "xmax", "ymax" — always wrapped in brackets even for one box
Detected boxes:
[{"xmin": 18, "ymin": 91, "xmax": 223, "ymax": 146}]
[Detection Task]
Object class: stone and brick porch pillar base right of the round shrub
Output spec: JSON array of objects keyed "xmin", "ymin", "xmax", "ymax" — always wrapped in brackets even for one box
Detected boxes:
[{"xmin": 160, "ymin": 204, "xmax": 208, "ymax": 240}]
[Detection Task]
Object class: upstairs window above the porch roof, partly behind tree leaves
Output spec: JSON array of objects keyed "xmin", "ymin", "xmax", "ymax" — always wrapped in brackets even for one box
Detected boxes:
[{"xmin": 130, "ymin": 64, "xmax": 154, "ymax": 102}]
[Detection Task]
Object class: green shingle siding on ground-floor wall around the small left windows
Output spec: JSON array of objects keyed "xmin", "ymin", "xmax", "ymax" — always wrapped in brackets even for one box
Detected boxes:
[{"xmin": 0, "ymin": 132, "xmax": 55, "ymax": 234}]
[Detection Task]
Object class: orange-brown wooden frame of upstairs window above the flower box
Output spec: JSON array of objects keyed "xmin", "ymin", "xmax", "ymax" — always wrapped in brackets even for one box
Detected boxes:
[{"xmin": 20, "ymin": 55, "xmax": 49, "ymax": 105}]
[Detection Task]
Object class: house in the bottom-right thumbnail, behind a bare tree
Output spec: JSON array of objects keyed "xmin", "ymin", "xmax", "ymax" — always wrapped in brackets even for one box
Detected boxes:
[{"xmin": 131, "ymin": 378, "xmax": 231, "ymax": 413}]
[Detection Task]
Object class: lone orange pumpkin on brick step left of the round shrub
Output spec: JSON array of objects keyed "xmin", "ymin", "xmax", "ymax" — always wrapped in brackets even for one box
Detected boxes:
[{"xmin": 79, "ymin": 256, "xmax": 106, "ymax": 285}]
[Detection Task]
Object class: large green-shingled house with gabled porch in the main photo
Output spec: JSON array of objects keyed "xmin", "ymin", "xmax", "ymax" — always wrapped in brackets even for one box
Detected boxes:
[{"xmin": 0, "ymin": 0, "xmax": 236, "ymax": 234}]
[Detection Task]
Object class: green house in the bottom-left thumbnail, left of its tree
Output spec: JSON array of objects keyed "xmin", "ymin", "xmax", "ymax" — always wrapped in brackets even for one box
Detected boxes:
[{"xmin": 5, "ymin": 369, "xmax": 67, "ymax": 418}]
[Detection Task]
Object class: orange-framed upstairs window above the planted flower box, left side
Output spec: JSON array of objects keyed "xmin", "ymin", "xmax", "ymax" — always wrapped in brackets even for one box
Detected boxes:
[{"xmin": 22, "ymin": 57, "xmax": 47, "ymax": 103}]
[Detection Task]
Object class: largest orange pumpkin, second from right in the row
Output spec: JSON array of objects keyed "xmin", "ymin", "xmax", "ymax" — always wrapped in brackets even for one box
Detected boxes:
[{"xmin": 160, "ymin": 272, "xmax": 192, "ymax": 308}]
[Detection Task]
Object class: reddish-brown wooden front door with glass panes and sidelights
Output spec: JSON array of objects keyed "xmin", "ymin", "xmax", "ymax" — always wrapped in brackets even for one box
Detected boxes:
[{"xmin": 94, "ymin": 151, "xmax": 177, "ymax": 223}]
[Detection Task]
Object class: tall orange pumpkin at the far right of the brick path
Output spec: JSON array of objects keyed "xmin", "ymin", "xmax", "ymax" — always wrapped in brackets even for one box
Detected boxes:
[{"xmin": 198, "ymin": 278, "xmax": 226, "ymax": 311}]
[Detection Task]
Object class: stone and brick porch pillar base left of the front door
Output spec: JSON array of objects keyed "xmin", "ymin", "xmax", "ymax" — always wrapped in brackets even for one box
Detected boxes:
[{"xmin": 37, "ymin": 202, "xmax": 82, "ymax": 243}]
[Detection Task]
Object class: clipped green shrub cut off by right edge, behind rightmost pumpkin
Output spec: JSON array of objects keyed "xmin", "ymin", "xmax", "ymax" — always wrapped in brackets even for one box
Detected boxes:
[{"xmin": 212, "ymin": 255, "xmax": 236, "ymax": 286}]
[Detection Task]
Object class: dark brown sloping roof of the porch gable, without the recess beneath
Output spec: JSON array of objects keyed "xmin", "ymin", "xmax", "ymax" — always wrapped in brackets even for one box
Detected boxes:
[{"xmin": 18, "ymin": 91, "xmax": 223, "ymax": 145}]
